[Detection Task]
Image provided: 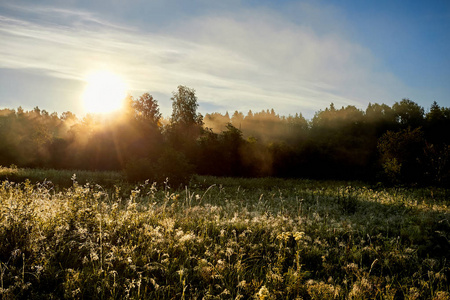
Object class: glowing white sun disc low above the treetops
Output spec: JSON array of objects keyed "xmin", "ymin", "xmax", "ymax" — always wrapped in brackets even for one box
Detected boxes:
[{"xmin": 82, "ymin": 70, "xmax": 127, "ymax": 114}]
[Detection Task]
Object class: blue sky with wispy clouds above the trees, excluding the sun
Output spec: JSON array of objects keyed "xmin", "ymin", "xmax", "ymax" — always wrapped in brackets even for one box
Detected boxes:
[{"xmin": 0, "ymin": 0, "xmax": 450, "ymax": 119}]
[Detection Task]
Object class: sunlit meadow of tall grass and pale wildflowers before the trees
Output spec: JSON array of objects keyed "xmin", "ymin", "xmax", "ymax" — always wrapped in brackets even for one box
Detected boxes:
[{"xmin": 0, "ymin": 168, "xmax": 450, "ymax": 299}]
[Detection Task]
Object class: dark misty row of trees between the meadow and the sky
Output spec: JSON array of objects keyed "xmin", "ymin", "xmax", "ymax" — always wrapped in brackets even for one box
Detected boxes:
[{"xmin": 0, "ymin": 86, "xmax": 450, "ymax": 185}]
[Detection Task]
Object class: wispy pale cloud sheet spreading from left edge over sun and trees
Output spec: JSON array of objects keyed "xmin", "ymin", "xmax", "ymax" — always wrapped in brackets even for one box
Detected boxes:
[{"xmin": 0, "ymin": 2, "xmax": 406, "ymax": 116}]
